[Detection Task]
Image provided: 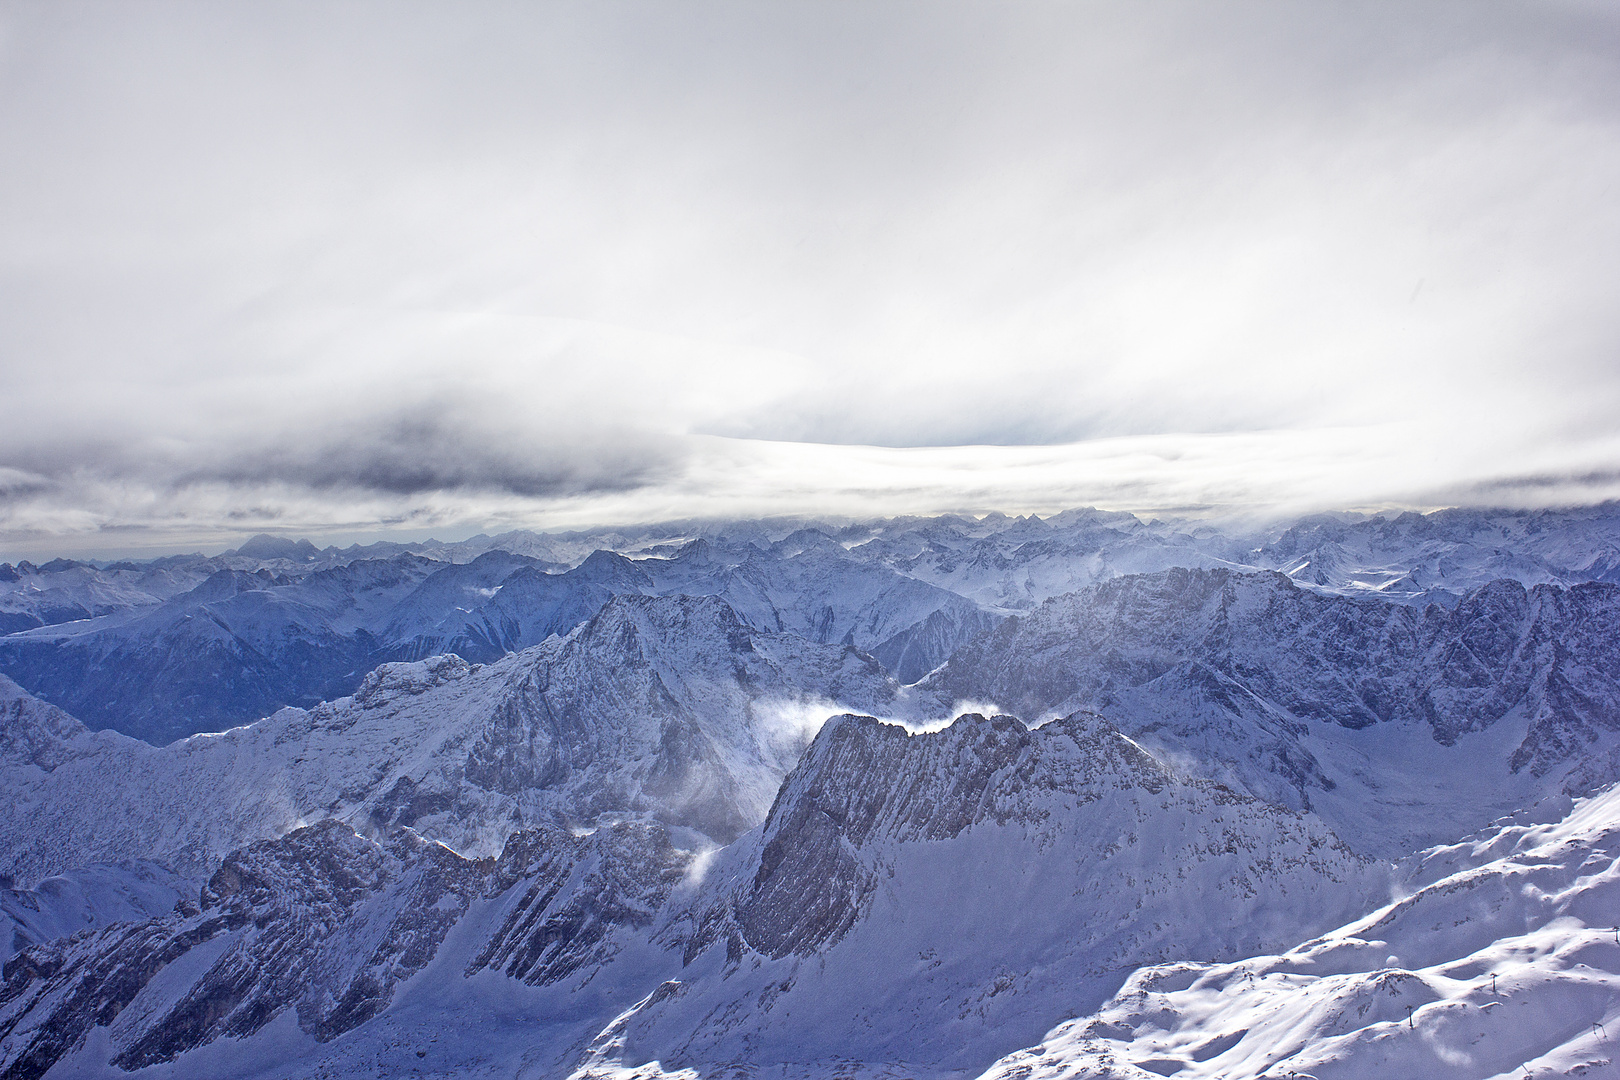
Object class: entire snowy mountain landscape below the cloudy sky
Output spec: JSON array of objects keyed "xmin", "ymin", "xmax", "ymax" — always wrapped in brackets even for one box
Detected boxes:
[{"xmin": 0, "ymin": 505, "xmax": 1620, "ymax": 1080}]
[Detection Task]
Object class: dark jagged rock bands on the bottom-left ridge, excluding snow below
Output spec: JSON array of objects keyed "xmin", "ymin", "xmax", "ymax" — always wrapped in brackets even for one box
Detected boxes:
[{"xmin": 0, "ymin": 821, "xmax": 687, "ymax": 1080}]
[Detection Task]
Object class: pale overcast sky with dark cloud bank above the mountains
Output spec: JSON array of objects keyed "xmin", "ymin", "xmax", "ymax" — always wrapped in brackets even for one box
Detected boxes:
[{"xmin": 0, "ymin": 0, "xmax": 1620, "ymax": 559}]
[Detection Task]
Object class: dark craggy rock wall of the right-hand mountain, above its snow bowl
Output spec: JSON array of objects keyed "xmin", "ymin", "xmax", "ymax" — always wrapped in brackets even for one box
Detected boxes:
[{"xmin": 930, "ymin": 570, "xmax": 1620, "ymax": 772}]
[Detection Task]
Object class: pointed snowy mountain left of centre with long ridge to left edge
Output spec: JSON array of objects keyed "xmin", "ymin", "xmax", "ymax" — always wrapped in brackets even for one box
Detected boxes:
[{"xmin": 0, "ymin": 597, "xmax": 897, "ymax": 884}]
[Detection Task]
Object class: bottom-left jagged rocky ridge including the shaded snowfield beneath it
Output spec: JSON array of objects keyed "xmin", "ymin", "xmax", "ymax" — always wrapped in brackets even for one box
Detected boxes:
[{"xmin": 0, "ymin": 821, "xmax": 690, "ymax": 1077}]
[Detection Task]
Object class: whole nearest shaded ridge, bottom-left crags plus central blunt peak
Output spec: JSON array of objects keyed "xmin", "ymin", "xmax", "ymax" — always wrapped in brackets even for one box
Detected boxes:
[{"xmin": 0, "ymin": 716, "xmax": 1387, "ymax": 1077}]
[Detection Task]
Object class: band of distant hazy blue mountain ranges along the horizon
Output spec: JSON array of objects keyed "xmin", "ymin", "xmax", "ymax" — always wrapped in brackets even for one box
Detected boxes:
[{"xmin": 9, "ymin": 507, "xmax": 1620, "ymax": 743}]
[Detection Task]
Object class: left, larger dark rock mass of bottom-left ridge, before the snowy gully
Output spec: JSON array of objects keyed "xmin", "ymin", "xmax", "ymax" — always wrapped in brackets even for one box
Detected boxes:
[{"xmin": 0, "ymin": 821, "xmax": 486, "ymax": 1077}]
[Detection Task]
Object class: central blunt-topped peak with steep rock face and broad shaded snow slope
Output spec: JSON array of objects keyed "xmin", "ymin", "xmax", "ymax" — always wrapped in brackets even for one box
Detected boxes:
[{"xmin": 567, "ymin": 716, "xmax": 1387, "ymax": 1075}]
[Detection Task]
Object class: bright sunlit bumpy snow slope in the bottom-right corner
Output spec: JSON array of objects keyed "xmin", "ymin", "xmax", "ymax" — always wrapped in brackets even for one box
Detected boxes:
[{"xmin": 983, "ymin": 789, "xmax": 1620, "ymax": 1080}]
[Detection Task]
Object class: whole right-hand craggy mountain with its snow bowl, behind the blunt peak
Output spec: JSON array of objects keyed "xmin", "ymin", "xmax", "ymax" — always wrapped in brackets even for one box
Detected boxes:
[{"xmin": 920, "ymin": 570, "xmax": 1620, "ymax": 857}]
